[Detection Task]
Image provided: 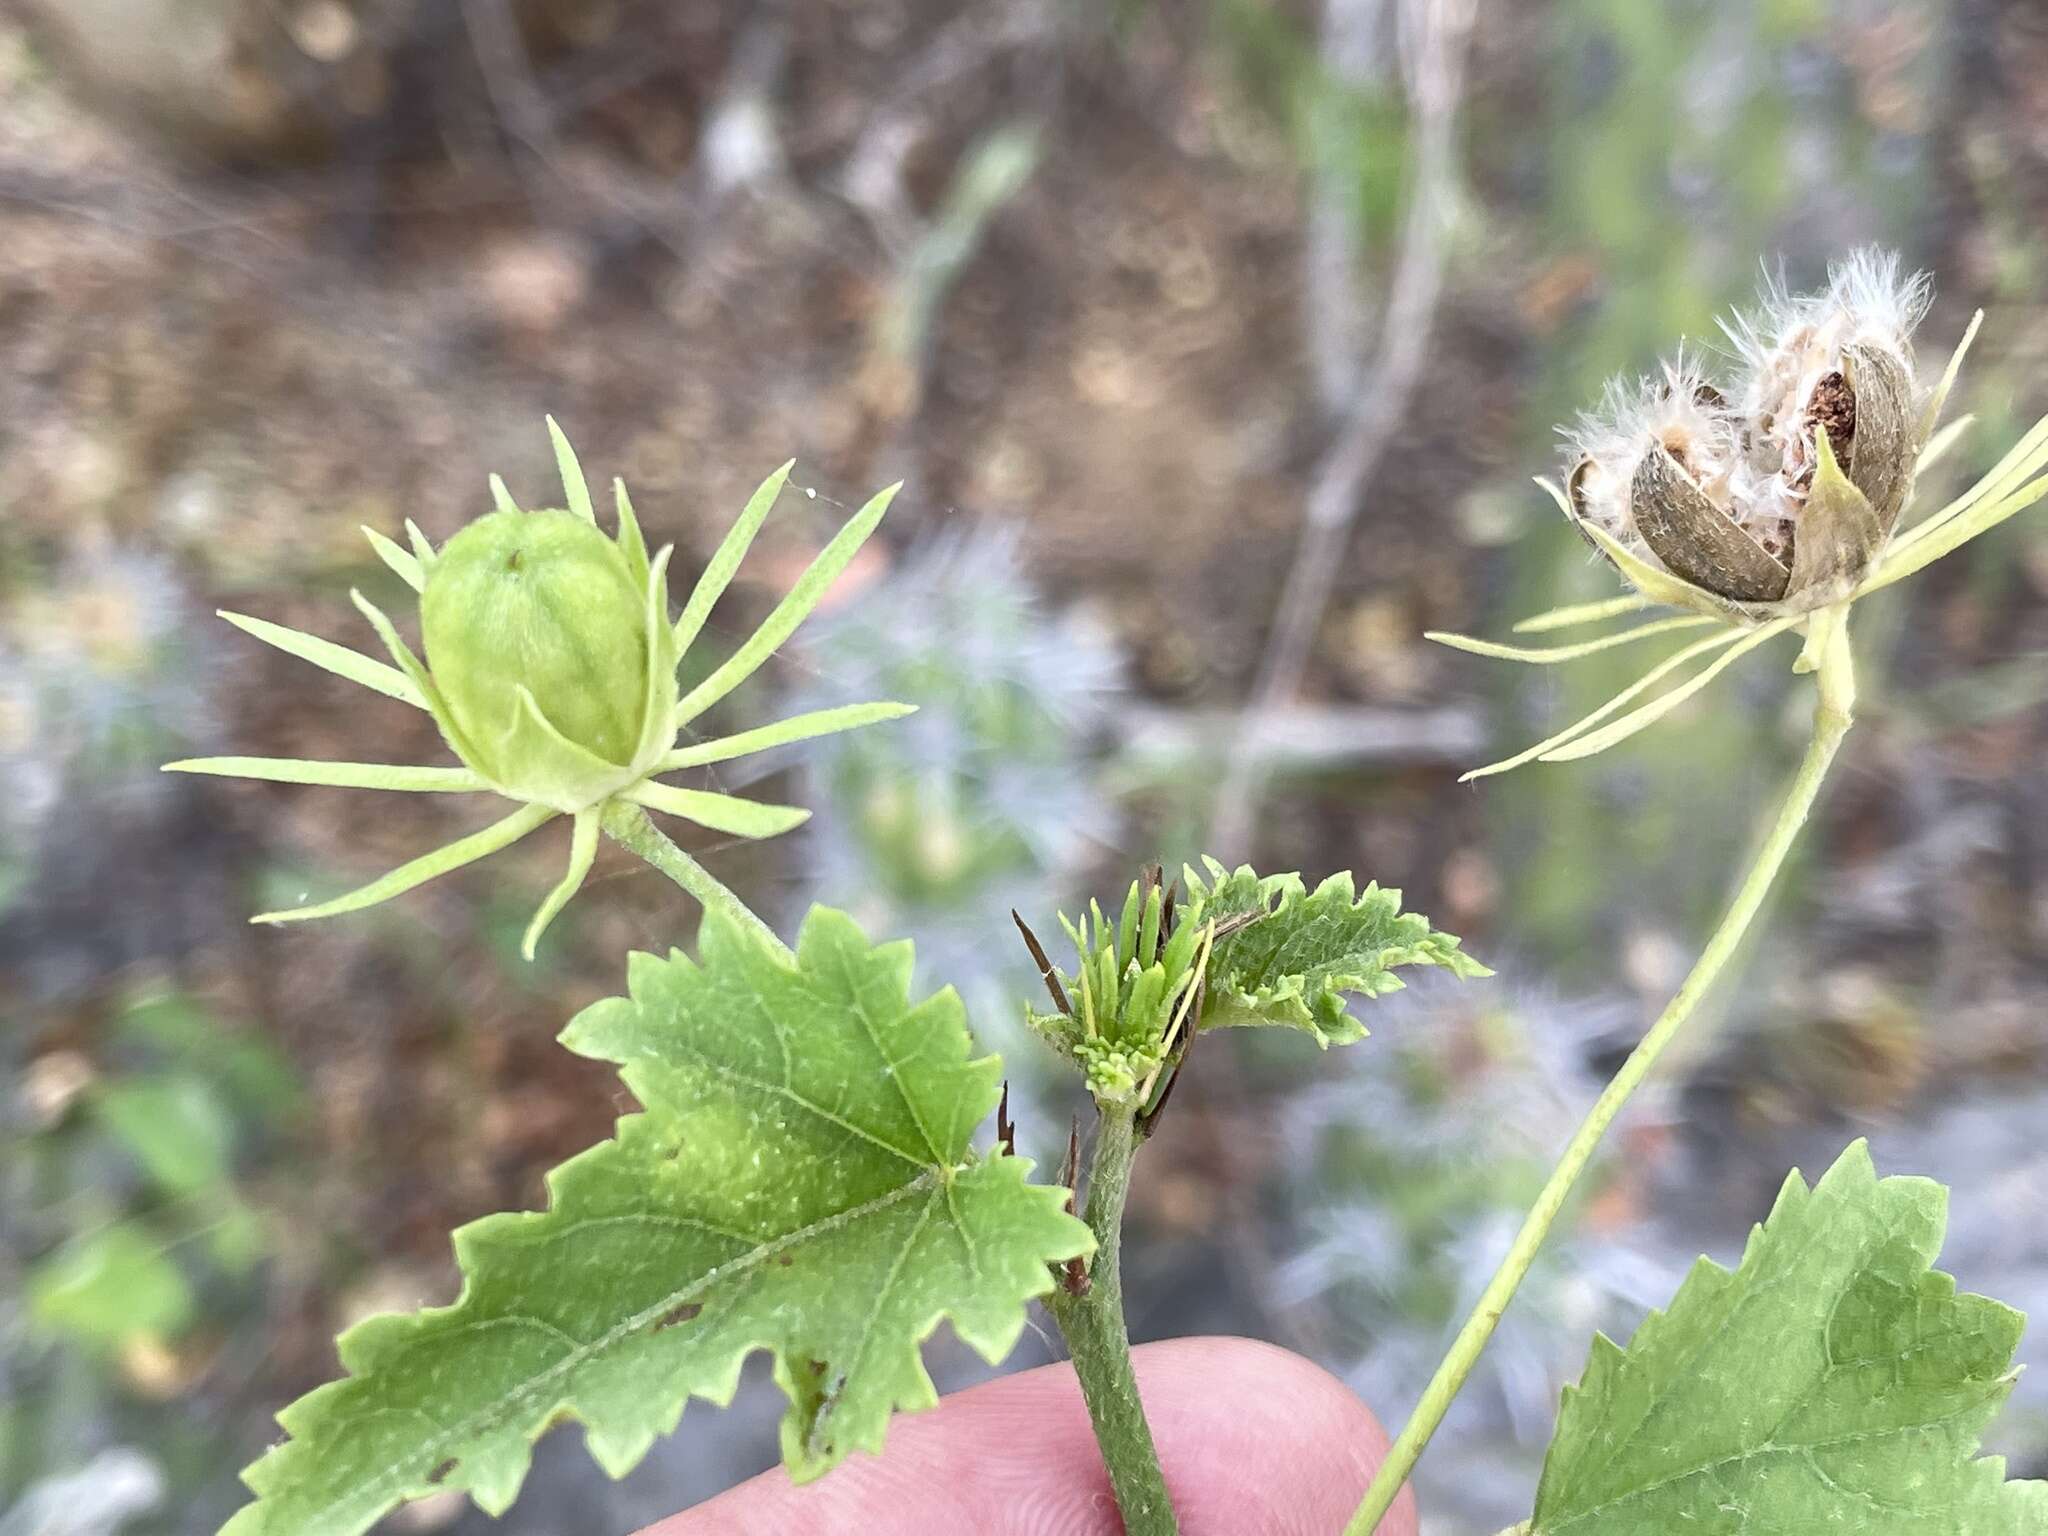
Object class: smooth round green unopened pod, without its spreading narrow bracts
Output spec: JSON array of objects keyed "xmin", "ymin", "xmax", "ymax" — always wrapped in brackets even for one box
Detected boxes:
[{"xmin": 420, "ymin": 512, "xmax": 676, "ymax": 811}]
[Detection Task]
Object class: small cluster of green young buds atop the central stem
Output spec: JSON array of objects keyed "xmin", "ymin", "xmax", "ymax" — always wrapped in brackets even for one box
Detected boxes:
[{"xmin": 1028, "ymin": 872, "xmax": 1210, "ymax": 1112}]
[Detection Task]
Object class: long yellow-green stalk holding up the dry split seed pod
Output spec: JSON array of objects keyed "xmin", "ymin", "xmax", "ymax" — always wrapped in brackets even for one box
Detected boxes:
[{"xmin": 1343, "ymin": 608, "xmax": 1855, "ymax": 1536}]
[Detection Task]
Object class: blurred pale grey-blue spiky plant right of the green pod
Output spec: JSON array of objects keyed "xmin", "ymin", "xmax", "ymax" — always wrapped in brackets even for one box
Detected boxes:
[{"xmin": 788, "ymin": 526, "xmax": 1122, "ymax": 995}]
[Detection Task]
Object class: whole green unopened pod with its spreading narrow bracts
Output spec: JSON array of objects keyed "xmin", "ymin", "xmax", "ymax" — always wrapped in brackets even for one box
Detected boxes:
[{"xmin": 164, "ymin": 418, "xmax": 909, "ymax": 961}]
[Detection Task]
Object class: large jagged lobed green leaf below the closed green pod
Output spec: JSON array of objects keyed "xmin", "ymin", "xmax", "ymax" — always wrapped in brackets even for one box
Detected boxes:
[{"xmin": 227, "ymin": 909, "xmax": 1094, "ymax": 1536}]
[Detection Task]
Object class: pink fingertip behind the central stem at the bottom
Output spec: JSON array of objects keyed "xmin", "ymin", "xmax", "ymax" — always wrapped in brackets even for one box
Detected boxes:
[{"xmin": 641, "ymin": 1337, "xmax": 1417, "ymax": 1536}]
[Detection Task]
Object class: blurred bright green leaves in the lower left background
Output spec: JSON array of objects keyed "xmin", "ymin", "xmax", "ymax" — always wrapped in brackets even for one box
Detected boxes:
[{"xmin": 0, "ymin": 989, "xmax": 305, "ymax": 1528}]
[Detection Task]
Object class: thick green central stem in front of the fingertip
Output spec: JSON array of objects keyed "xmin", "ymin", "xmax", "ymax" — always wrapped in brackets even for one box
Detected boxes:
[{"xmin": 1047, "ymin": 1108, "xmax": 1180, "ymax": 1536}]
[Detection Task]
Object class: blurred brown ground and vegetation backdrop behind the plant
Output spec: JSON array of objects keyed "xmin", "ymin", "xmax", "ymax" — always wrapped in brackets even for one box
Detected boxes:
[{"xmin": 0, "ymin": 0, "xmax": 2048, "ymax": 1536}]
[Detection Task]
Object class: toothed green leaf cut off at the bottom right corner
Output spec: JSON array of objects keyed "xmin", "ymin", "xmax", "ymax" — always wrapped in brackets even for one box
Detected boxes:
[{"xmin": 1526, "ymin": 1141, "xmax": 2048, "ymax": 1536}]
